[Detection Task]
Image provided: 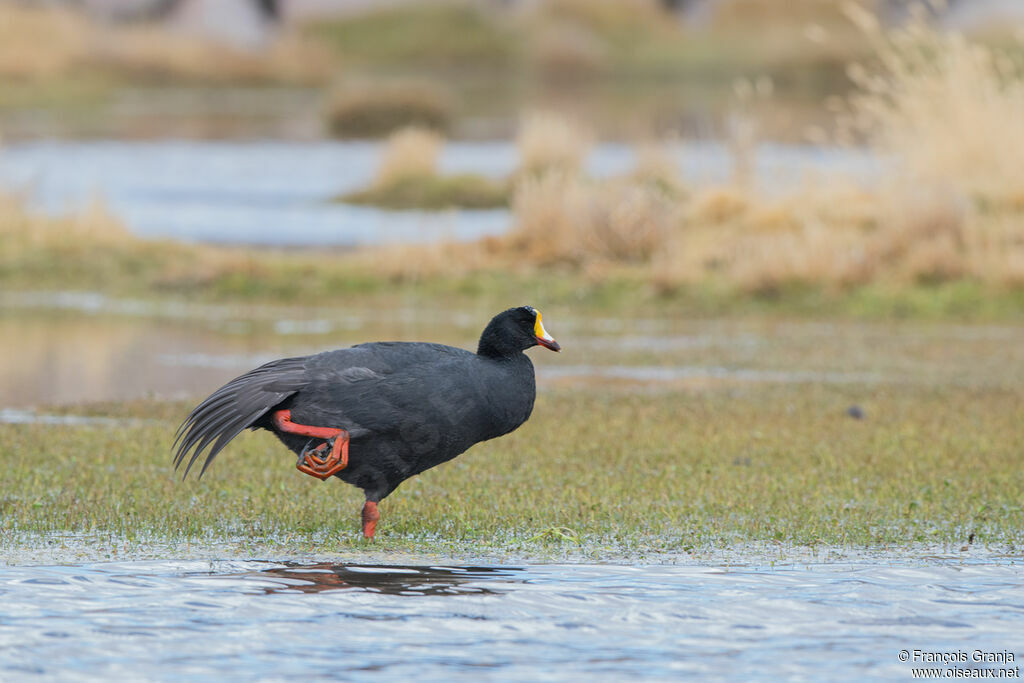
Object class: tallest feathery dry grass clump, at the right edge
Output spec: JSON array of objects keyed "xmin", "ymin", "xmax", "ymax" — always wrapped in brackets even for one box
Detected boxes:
[{"xmin": 831, "ymin": 11, "xmax": 1024, "ymax": 285}]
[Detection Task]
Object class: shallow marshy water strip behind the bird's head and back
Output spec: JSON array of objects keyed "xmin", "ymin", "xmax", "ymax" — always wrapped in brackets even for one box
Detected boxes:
[{"xmin": 0, "ymin": 301, "xmax": 1024, "ymax": 411}]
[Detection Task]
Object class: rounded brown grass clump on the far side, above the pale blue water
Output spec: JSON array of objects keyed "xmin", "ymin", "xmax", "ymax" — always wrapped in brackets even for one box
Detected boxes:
[{"xmin": 326, "ymin": 83, "xmax": 453, "ymax": 137}]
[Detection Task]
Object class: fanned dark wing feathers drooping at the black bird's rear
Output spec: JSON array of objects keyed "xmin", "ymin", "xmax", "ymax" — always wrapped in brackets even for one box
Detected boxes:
[{"xmin": 172, "ymin": 357, "xmax": 308, "ymax": 476}]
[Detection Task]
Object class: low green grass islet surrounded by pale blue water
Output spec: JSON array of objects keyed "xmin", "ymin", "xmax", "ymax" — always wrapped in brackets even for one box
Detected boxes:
[{"xmin": 337, "ymin": 173, "xmax": 509, "ymax": 210}]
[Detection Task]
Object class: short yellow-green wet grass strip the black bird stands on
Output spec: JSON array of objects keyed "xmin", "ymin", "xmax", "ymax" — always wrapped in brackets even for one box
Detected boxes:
[{"xmin": 0, "ymin": 384, "xmax": 1024, "ymax": 555}]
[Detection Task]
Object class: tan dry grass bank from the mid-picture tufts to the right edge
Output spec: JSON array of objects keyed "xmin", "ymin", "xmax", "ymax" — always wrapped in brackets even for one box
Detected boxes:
[{"xmin": 501, "ymin": 14, "xmax": 1024, "ymax": 291}]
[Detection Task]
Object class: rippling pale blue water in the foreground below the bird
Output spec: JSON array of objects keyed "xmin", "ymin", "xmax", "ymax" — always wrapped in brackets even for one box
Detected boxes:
[{"xmin": 0, "ymin": 559, "xmax": 1024, "ymax": 680}]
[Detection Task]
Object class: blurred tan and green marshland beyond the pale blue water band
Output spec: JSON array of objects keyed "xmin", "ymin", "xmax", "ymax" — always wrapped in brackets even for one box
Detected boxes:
[{"xmin": 0, "ymin": 0, "xmax": 954, "ymax": 139}]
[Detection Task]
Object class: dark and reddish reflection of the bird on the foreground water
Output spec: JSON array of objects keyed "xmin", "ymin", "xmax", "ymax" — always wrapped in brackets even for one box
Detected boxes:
[{"xmin": 253, "ymin": 562, "xmax": 522, "ymax": 596}]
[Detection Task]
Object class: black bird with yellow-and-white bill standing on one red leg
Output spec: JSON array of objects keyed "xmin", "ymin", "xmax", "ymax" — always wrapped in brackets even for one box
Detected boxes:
[{"xmin": 174, "ymin": 306, "xmax": 560, "ymax": 539}]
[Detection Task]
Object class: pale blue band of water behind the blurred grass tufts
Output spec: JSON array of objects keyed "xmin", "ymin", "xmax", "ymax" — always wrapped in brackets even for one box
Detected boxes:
[{"xmin": 0, "ymin": 140, "xmax": 873, "ymax": 246}]
